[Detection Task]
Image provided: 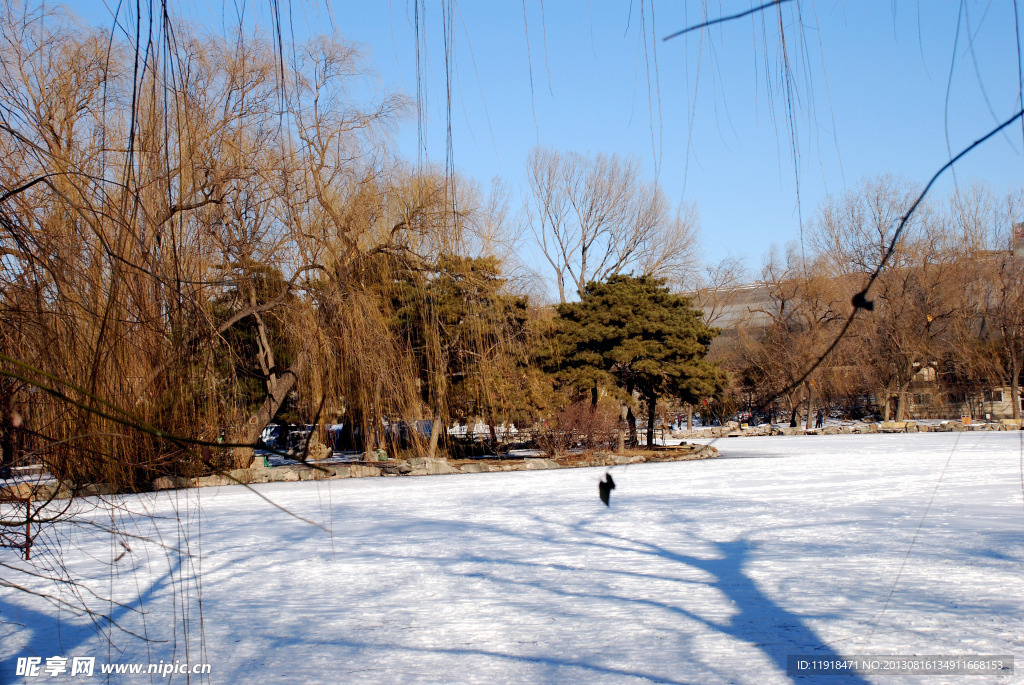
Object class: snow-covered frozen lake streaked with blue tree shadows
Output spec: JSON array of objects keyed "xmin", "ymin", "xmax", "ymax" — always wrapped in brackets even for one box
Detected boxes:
[{"xmin": 0, "ymin": 432, "xmax": 1024, "ymax": 683}]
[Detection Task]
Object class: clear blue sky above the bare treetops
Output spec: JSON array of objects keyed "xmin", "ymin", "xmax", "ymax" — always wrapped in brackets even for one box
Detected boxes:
[{"xmin": 69, "ymin": 0, "xmax": 1024, "ymax": 276}]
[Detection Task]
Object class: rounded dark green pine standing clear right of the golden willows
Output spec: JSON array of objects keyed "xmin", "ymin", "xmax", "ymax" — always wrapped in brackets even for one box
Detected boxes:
[{"xmin": 555, "ymin": 275, "xmax": 724, "ymax": 445}]
